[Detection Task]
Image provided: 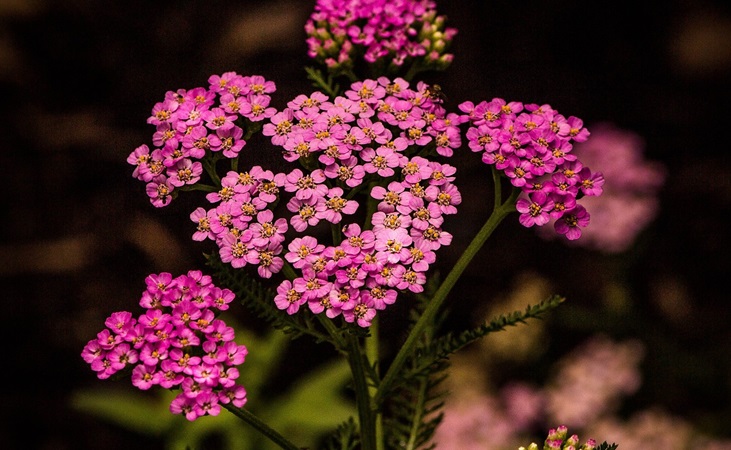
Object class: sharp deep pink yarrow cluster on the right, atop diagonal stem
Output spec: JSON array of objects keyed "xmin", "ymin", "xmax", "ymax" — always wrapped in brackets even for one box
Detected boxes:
[{"xmin": 459, "ymin": 98, "xmax": 604, "ymax": 240}]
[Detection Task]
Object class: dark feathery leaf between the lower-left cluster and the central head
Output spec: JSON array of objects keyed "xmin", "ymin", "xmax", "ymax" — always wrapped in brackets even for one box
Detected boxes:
[{"xmin": 205, "ymin": 253, "xmax": 338, "ymax": 348}]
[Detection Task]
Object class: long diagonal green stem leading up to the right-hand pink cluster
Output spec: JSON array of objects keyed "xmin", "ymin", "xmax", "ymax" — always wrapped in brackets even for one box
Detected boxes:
[{"xmin": 373, "ymin": 169, "xmax": 520, "ymax": 407}]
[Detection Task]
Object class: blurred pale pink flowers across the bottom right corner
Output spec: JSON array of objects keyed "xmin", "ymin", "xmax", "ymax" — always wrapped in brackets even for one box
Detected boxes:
[{"xmin": 435, "ymin": 335, "xmax": 731, "ymax": 450}]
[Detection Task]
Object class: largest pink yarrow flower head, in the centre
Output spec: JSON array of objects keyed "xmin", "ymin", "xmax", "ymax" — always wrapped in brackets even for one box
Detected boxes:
[{"xmin": 191, "ymin": 77, "xmax": 461, "ymax": 327}]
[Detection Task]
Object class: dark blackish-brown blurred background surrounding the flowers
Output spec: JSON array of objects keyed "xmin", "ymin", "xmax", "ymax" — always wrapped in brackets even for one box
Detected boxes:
[{"xmin": 0, "ymin": 0, "xmax": 731, "ymax": 450}]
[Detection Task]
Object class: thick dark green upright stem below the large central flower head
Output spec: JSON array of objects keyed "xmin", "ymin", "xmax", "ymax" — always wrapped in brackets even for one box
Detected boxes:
[{"xmin": 347, "ymin": 334, "xmax": 378, "ymax": 450}]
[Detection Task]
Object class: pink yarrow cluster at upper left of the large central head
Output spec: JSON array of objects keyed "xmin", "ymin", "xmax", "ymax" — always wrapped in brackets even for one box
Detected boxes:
[{"xmin": 127, "ymin": 72, "xmax": 276, "ymax": 207}]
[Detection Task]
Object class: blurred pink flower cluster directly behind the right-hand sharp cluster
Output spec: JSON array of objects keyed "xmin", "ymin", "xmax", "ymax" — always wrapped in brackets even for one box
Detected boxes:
[{"xmin": 539, "ymin": 123, "xmax": 666, "ymax": 253}]
